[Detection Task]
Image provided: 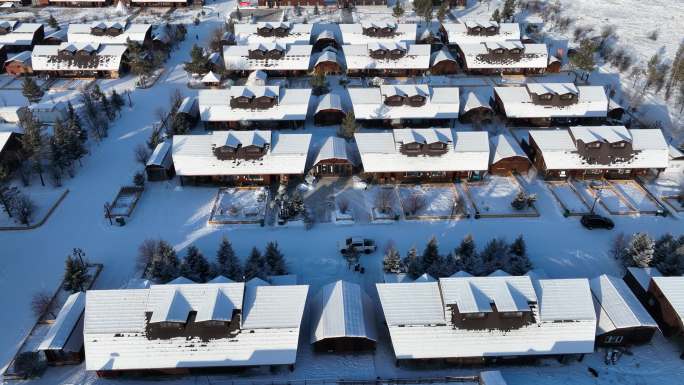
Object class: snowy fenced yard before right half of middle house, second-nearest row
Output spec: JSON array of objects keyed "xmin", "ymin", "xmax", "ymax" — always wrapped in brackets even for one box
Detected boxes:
[{"xmin": 397, "ymin": 184, "xmax": 459, "ymax": 219}]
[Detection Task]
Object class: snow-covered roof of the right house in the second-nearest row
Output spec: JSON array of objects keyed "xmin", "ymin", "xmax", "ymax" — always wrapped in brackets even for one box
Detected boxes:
[{"xmin": 529, "ymin": 126, "xmax": 669, "ymax": 170}]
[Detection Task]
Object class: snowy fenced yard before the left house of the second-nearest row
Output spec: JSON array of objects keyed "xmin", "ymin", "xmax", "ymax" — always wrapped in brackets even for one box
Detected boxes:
[{"xmin": 209, "ymin": 187, "xmax": 268, "ymax": 223}]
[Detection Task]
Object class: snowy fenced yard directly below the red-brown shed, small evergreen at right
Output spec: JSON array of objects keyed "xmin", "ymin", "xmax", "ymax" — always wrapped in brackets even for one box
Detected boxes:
[{"xmin": 467, "ymin": 175, "xmax": 535, "ymax": 216}]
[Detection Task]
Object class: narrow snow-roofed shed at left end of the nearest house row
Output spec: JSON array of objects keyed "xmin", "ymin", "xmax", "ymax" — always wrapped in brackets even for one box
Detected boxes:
[{"xmin": 38, "ymin": 292, "xmax": 86, "ymax": 366}]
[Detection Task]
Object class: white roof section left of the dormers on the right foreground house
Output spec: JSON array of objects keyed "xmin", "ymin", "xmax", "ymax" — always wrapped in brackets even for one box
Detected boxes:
[{"xmin": 376, "ymin": 282, "xmax": 446, "ymax": 326}]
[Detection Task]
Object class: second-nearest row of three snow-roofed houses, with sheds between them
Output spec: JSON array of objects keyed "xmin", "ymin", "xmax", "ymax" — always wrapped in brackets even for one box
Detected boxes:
[{"xmin": 147, "ymin": 126, "xmax": 669, "ymax": 185}]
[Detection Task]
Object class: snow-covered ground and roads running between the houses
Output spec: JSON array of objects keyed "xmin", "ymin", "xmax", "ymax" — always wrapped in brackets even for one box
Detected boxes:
[{"xmin": 0, "ymin": 0, "xmax": 684, "ymax": 385}]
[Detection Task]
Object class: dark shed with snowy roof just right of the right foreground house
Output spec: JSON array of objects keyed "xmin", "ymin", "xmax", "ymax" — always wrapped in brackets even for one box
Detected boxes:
[{"xmin": 589, "ymin": 274, "xmax": 658, "ymax": 347}]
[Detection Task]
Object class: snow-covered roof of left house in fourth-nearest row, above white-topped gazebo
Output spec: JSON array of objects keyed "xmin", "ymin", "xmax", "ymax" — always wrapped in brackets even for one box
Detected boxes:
[{"xmin": 223, "ymin": 43, "xmax": 313, "ymax": 71}]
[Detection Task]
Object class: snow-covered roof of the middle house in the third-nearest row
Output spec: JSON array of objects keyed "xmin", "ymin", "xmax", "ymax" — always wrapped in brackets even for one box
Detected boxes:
[{"xmin": 348, "ymin": 84, "xmax": 459, "ymax": 119}]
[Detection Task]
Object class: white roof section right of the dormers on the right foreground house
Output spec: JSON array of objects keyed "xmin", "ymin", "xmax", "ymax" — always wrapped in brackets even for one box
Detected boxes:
[{"xmin": 538, "ymin": 278, "xmax": 596, "ymax": 322}]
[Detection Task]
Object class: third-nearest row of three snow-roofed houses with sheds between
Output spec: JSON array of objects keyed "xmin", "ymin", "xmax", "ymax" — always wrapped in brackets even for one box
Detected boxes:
[{"xmin": 190, "ymin": 82, "xmax": 624, "ymax": 129}]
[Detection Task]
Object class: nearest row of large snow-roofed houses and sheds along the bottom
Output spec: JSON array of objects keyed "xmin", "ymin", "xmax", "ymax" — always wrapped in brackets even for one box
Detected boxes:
[{"xmin": 39, "ymin": 268, "xmax": 684, "ymax": 377}]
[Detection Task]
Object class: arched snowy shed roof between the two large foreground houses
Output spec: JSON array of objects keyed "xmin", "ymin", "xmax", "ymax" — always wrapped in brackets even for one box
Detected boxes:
[{"xmin": 311, "ymin": 281, "xmax": 377, "ymax": 343}]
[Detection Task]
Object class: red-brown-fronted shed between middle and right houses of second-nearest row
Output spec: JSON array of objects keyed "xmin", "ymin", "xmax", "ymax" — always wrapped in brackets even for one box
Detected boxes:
[{"xmin": 489, "ymin": 134, "xmax": 531, "ymax": 175}]
